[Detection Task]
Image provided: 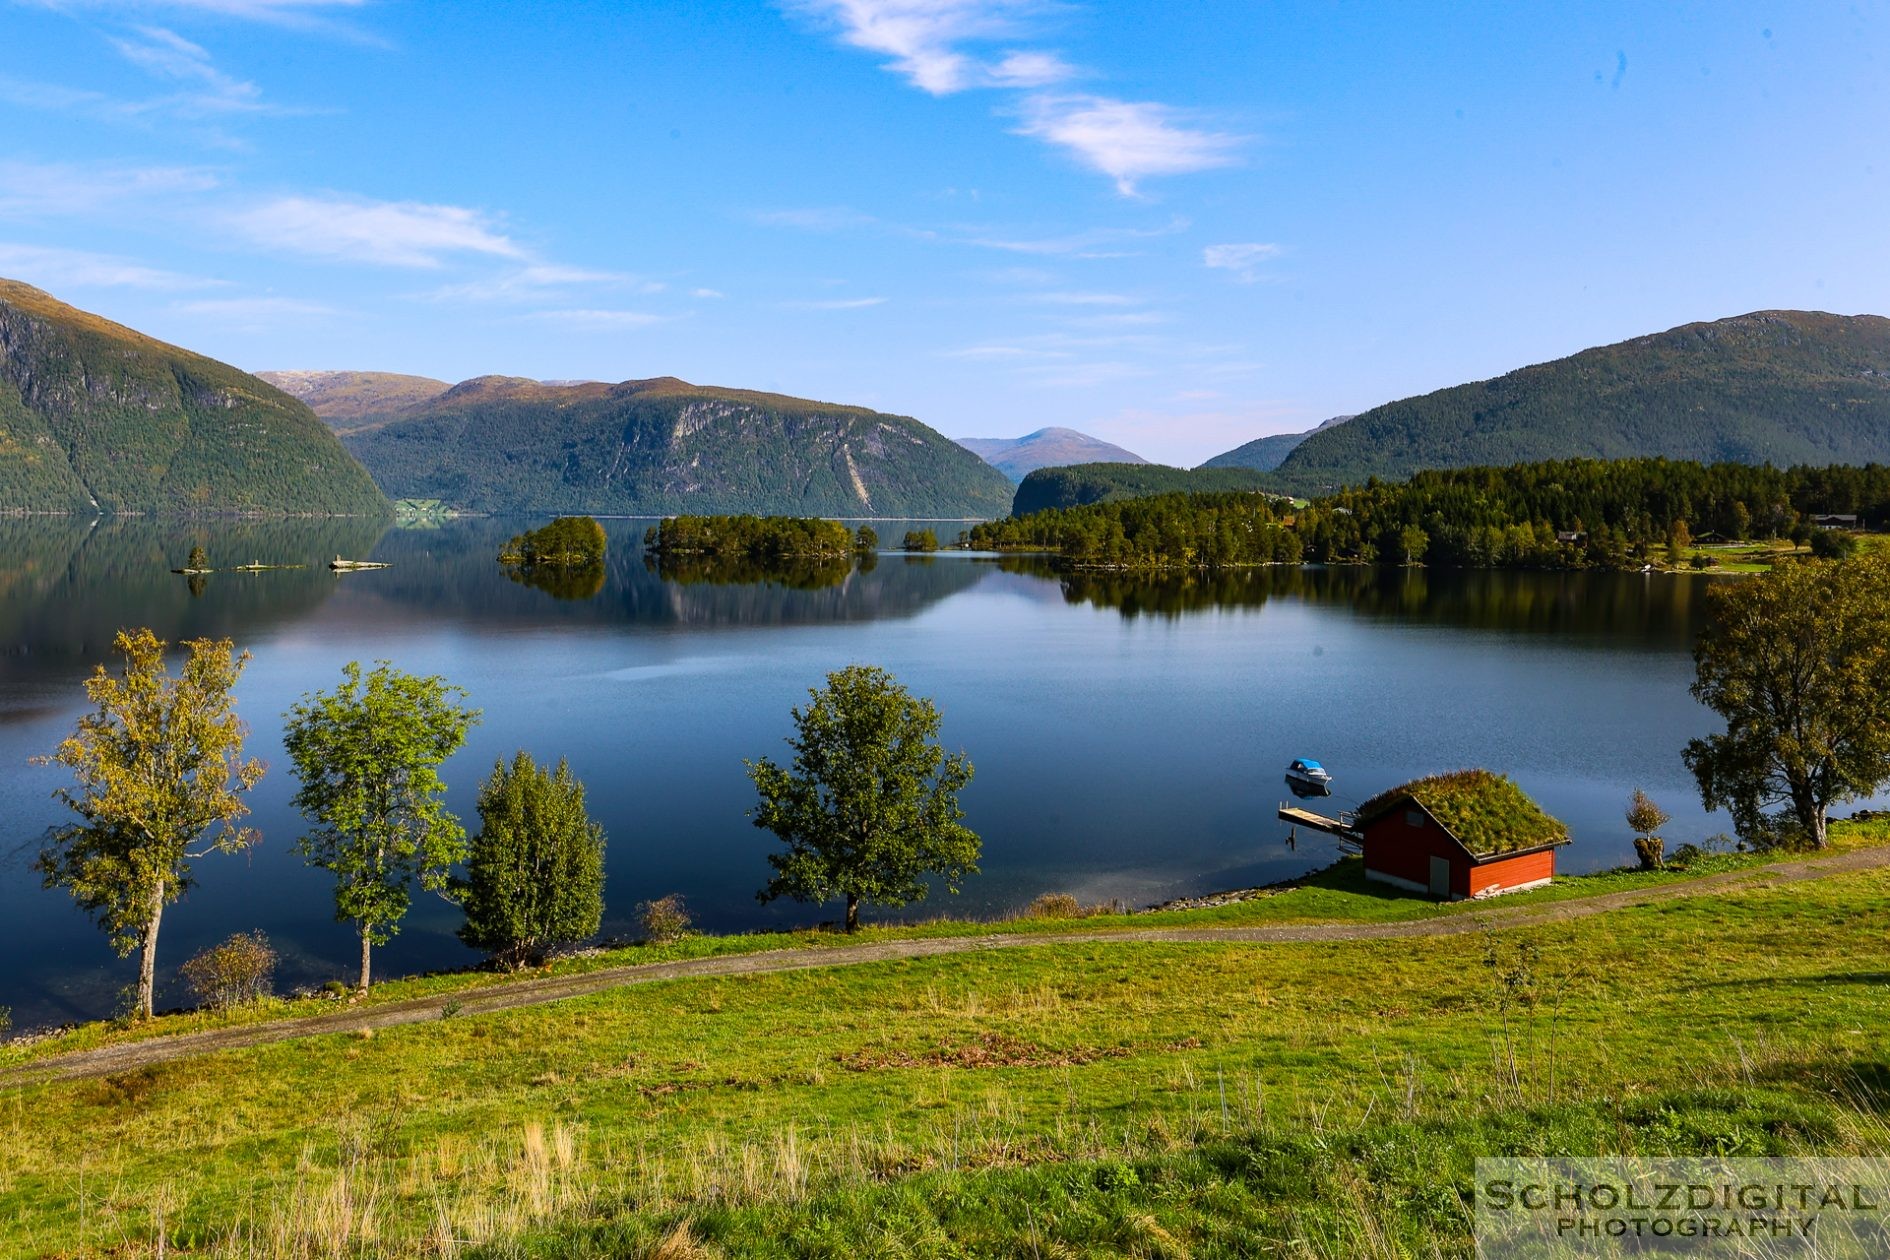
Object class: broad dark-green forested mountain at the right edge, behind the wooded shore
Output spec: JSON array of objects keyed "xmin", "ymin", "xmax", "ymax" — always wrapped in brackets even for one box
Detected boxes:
[{"xmin": 1276, "ymin": 310, "xmax": 1890, "ymax": 493}]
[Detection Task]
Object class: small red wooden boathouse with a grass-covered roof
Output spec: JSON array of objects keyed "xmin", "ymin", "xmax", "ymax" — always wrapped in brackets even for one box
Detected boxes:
[{"xmin": 1357, "ymin": 771, "xmax": 1569, "ymax": 901}]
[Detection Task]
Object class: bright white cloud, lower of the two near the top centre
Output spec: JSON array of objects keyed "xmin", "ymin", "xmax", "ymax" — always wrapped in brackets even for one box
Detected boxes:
[{"xmin": 1017, "ymin": 94, "xmax": 1244, "ymax": 196}]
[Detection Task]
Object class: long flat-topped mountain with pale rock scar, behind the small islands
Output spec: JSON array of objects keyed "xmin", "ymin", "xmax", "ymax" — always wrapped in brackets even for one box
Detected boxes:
[{"xmin": 346, "ymin": 376, "xmax": 1011, "ymax": 518}]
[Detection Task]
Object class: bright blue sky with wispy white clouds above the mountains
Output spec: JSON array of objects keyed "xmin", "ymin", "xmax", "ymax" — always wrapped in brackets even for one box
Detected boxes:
[{"xmin": 0, "ymin": 0, "xmax": 1890, "ymax": 463}]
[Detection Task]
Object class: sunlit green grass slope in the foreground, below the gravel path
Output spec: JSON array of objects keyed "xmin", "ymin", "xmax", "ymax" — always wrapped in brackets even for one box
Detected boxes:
[{"xmin": 0, "ymin": 824, "xmax": 1890, "ymax": 1258}]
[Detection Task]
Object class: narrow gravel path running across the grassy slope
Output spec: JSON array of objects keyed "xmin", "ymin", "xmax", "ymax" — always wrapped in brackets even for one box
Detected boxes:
[{"xmin": 0, "ymin": 848, "xmax": 1890, "ymax": 1088}]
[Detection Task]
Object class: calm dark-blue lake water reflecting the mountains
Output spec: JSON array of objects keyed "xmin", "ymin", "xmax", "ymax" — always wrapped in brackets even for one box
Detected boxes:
[{"xmin": 0, "ymin": 521, "xmax": 1761, "ymax": 1028}]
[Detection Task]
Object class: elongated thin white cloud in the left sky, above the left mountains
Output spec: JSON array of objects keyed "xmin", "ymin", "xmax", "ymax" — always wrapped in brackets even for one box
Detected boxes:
[{"xmin": 227, "ymin": 195, "xmax": 527, "ymax": 268}]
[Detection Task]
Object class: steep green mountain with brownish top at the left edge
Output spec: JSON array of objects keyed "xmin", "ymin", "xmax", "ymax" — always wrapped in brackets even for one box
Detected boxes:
[{"xmin": 0, "ymin": 280, "xmax": 387, "ymax": 516}]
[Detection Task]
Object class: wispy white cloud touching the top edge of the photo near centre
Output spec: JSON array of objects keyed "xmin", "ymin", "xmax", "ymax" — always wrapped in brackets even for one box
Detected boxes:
[{"xmin": 794, "ymin": 0, "xmax": 1074, "ymax": 96}]
